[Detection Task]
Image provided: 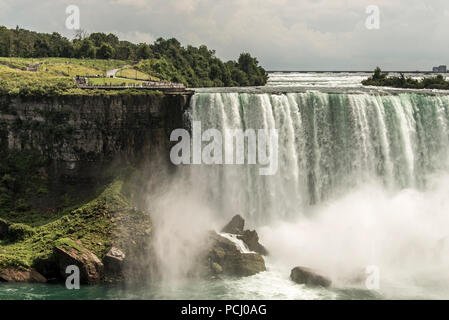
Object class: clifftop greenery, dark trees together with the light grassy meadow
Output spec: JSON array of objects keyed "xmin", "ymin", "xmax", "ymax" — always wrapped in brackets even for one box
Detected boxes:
[{"xmin": 0, "ymin": 26, "xmax": 268, "ymax": 90}]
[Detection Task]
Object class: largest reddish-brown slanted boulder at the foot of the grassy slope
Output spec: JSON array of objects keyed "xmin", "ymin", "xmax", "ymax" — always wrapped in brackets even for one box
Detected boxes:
[{"xmin": 54, "ymin": 238, "xmax": 104, "ymax": 284}]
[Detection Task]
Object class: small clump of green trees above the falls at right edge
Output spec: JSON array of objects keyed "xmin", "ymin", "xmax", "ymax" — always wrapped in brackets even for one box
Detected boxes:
[{"xmin": 362, "ymin": 67, "xmax": 449, "ymax": 90}]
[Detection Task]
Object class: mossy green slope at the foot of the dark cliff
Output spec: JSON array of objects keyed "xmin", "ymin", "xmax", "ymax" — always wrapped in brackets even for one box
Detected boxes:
[{"xmin": 0, "ymin": 177, "xmax": 151, "ymax": 269}]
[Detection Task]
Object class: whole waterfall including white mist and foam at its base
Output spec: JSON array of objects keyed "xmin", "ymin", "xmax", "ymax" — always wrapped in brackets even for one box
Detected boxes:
[{"xmin": 165, "ymin": 87, "xmax": 449, "ymax": 298}]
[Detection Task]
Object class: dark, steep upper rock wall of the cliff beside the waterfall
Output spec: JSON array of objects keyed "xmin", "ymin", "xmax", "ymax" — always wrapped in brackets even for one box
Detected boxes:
[{"xmin": 0, "ymin": 94, "xmax": 190, "ymax": 178}]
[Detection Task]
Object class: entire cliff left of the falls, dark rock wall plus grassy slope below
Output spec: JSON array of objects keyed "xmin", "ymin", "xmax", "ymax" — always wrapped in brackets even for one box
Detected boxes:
[{"xmin": 0, "ymin": 93, "xmax": 190, "ymax": 281}]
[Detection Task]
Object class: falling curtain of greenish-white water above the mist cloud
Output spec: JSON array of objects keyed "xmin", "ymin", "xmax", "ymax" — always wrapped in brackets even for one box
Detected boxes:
[{"xmin": 191, "ymin": 91, "xmax": 449, "ymax": 222}]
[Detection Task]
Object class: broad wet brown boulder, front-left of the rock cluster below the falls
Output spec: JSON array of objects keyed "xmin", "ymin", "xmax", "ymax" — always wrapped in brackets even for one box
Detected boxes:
[{"xmin": 206, "ymin": 232, "xmax": 266, "ymax": 276}]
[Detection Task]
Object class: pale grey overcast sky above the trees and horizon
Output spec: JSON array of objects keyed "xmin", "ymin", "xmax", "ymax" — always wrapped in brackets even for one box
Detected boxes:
[{"xmin": 0, "ymin": 0, "xmax": 449, "ymax": 70}]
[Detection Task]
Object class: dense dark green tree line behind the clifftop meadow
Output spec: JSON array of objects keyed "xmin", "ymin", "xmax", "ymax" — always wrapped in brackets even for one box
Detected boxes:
[{"xmin": 0, "ymin": 26, "xmax": 268, "ymax": 87}]
